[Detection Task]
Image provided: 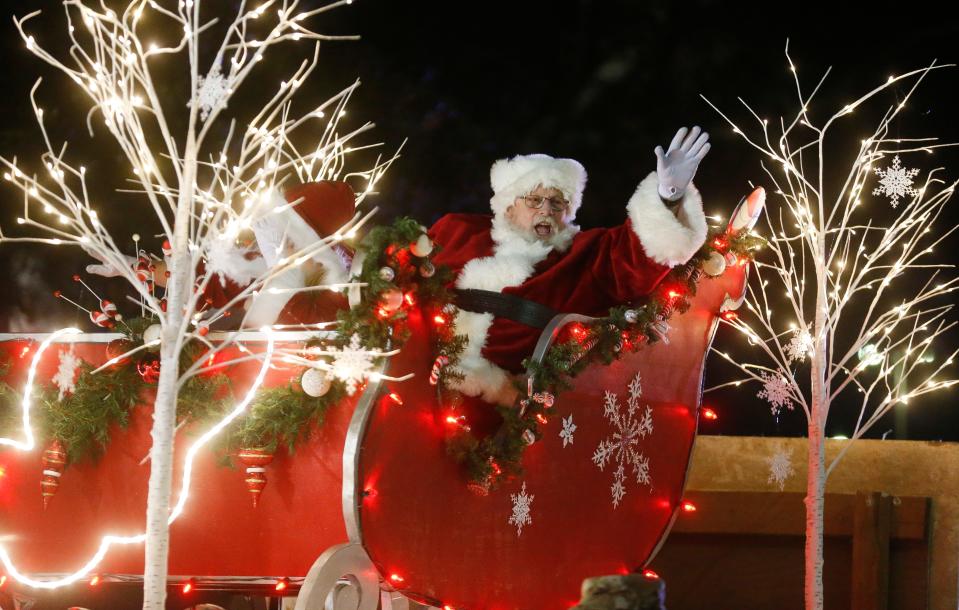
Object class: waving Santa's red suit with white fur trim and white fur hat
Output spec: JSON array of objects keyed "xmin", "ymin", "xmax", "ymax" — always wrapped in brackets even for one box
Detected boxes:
[{"xmin": 429, "ymin": 155, "xmax": 707, "ymax": 404}]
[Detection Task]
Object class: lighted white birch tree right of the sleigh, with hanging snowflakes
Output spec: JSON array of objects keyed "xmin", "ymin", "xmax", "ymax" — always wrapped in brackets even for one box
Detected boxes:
[{"xmin": 707, "ymin": 46, "xmax": 957, "ymax": 610}]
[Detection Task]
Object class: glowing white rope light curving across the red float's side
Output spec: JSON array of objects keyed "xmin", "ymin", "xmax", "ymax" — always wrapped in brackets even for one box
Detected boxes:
[{"xmin": 0, "ymin": 327, "xmax": 274, "ymax": 589}]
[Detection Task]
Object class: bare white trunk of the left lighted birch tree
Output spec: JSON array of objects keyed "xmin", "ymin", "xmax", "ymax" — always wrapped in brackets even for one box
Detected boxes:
[{"xmin": 143, "ymin": 145, "xmax": 196, "ymax": 610}]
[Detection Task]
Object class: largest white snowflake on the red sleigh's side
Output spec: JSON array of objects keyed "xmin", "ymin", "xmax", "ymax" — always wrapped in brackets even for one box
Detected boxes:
[{"xmin": 593, "ymin": 373, "xmax": 653, "ymax": 508}]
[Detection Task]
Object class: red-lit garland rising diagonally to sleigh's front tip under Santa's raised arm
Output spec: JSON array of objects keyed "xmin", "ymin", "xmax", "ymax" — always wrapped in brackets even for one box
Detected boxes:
[{"xmin": 447, "ymin": 228, "xmax": 765, "ymax": 493}]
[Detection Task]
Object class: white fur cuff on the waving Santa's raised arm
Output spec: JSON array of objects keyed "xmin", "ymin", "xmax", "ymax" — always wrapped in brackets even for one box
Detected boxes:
[{"xmin": 626, "ymin": 172, "xmax": 707, "ymax": 267}]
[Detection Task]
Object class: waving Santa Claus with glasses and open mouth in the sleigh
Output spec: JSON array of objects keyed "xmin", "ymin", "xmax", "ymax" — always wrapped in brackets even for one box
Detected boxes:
[{"xmin": 429, "ymin": 127, "xmax": 710, "ymax": 405}]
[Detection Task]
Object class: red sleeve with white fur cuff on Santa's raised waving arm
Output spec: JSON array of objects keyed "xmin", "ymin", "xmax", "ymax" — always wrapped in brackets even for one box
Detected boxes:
[{"xmin": 591, "ymin": 172, "xmax": 706, "ymax": 303}]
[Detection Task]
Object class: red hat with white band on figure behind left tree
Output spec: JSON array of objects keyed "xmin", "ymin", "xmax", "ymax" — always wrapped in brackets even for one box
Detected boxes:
[{"xmin": 275, "ymin": 180, "xmax": 356, "ymax": 249}]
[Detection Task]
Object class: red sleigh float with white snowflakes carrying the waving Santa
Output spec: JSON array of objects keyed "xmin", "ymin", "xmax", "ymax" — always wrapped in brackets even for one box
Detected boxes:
[{"xmin": 0, "ymin": 192, "xmax": 764, "ymax": 610}]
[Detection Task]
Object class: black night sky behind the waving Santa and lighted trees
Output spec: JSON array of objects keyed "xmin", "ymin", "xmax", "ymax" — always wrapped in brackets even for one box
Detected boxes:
[{"xmin": 0, "ymin": 0, "xmax": 959, "ymax": 440}]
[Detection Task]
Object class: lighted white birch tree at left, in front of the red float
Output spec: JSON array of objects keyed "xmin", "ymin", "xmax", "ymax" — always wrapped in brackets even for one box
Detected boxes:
[{"xmin": 0, "ymin": 0, "xmax": 395, "ymax": 609}]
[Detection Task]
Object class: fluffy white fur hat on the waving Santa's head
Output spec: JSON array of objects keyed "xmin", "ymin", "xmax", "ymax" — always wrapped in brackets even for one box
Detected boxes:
[{"xmin": 490, "ymin": 155, "xmax": 586, "ymax": 218}]
